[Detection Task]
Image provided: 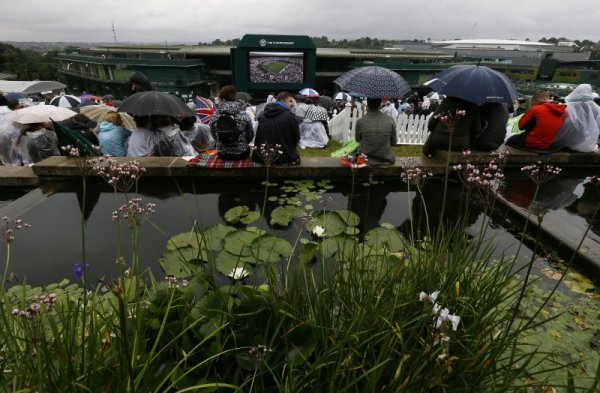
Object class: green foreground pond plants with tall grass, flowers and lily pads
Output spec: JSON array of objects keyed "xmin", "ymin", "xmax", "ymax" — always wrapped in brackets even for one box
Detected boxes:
[{"xmin": 0, "ymin": 152, "xmax": 596, "ymax": 393}]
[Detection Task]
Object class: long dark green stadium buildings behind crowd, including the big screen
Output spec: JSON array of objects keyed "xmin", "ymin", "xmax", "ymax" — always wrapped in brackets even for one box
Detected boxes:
[{"xmin": 57, "ymin": 35, "xmax": 600, "ymax": 98}]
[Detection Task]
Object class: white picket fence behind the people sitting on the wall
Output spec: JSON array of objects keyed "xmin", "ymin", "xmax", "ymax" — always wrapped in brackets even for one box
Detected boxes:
[{"xmin": 328, "ymin": 104, "xmax": 432, "ymax": 145}]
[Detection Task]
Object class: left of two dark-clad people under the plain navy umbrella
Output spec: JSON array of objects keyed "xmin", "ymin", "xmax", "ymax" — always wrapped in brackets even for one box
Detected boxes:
[{"xmin": 423, "ymin": 97, "xmax": 481, "ymax": 156}]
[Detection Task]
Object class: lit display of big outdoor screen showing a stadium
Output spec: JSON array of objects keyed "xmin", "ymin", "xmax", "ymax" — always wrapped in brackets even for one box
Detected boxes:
[{"xmin": 249, "ymin": 52, "xmax": 304, "ymax": 84}]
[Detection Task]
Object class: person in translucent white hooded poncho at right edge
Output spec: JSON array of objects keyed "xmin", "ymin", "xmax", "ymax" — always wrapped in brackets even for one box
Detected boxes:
[{"xmin": 552, "ymin": 83, "xmax": 600, "ymax": 153}]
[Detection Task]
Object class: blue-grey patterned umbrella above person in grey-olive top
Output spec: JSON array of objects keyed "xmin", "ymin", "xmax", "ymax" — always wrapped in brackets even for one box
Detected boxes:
[{"xmin": 333, "ymin": 66, "xmax": 410, "ymax": 98}]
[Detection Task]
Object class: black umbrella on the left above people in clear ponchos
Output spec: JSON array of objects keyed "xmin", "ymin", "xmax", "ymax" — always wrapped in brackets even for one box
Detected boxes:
[{"xmin": 117, "ymin": 90, "xmax": 195, "ymax": 117}]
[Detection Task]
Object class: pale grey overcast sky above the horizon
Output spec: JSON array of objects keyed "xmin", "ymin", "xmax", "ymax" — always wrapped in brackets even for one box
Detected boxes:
[{"xmin": 0, "ymin": 0, "xmax": 600, "ymax": 43}]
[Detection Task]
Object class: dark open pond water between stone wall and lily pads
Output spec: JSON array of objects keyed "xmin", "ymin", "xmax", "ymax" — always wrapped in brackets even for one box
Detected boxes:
[{"xmin": 0, "ymin": 169, "xmax": 600, "ymax": 285}]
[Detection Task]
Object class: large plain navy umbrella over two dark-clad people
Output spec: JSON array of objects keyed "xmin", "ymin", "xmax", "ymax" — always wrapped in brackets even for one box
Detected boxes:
[{"xmin": 425, "ymin": 65, "xmax": 517, "ymax": 105}]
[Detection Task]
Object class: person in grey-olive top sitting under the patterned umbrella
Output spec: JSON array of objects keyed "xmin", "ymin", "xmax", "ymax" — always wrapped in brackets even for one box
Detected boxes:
[{"xmin": 355, "ymin": 98, "xmax": 398, "ymax": 166}]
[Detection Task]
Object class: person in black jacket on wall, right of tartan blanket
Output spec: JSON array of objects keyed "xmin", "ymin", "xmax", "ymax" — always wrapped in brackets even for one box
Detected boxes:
[{"xmin": 252, "ymin": 91, "xmax": 300, "ymax": 164}]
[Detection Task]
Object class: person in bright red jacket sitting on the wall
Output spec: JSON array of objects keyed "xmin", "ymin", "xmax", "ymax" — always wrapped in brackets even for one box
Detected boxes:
[{"xmin": 506, "ymin": 90, "xmax": 567, "ymax": 152}]
